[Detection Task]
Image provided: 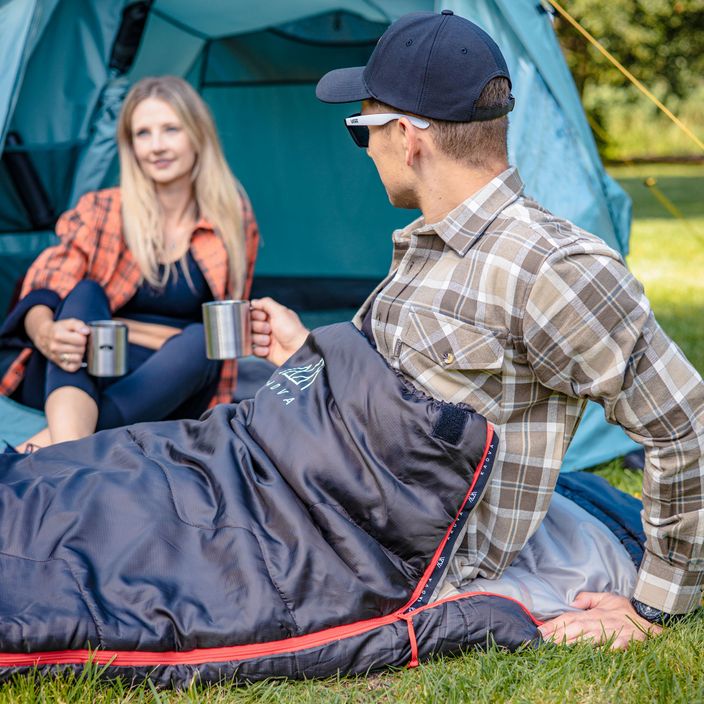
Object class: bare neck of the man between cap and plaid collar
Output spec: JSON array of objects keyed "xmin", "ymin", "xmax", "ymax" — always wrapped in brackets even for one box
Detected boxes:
[{"xmin": 418, "ymin": 162, "xmax": 508, "ymax": 224}]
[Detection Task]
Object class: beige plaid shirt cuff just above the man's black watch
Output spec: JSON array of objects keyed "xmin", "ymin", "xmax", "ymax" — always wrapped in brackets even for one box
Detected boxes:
[{"xmin": 633, "ymin": 552, "xmax": 703, "ymax": 615}]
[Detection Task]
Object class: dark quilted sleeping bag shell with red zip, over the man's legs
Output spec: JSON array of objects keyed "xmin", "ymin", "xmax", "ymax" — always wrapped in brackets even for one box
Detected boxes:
[{"xmin": 0, "ymin": 323, "xmax": 538, "ymax": 685}]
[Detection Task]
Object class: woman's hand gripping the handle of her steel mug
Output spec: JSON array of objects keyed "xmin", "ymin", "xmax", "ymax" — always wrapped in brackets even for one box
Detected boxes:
[{"xmin": 25, "ymin": 306, "xmax": 90, "ymax": 372}]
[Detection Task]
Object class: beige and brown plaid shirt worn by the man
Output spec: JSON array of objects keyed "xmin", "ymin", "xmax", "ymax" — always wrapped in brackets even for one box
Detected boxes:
[{"xmin": 355, "ymin": 169, "xmax": 704, "ymax": 613}]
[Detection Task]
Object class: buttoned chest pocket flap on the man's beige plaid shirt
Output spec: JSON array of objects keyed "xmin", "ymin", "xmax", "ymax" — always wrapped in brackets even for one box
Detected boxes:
[{"xmin": 401, "ymin": 310, "xmax": 504, "ymax": 370}]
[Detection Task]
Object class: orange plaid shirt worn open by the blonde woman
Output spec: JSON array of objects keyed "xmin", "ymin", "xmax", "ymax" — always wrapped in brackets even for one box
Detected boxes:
[{"xmin": 0, "ymin": 188, "xmax": 259, "ymax": 406}]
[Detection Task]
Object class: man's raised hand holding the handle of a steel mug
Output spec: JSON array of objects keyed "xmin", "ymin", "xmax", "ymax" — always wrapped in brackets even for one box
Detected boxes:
[{"xmin": 251, "ymin": 298, "xmax": 308, "ymax": 367}]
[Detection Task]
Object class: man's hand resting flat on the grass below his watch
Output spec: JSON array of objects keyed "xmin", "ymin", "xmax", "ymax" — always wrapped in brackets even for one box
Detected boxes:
[{"xmin": 539, "ymin": 592, "xmax": 662, "ymax": 649}]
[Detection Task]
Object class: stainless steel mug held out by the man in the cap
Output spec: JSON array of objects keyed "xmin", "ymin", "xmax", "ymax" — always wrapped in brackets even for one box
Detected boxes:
[{"xmin": 202, "ymin": 301, "xmax": 252, "ymax": 359}]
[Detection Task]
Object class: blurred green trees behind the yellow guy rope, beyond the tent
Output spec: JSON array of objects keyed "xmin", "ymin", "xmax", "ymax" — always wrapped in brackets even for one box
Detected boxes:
[{"xmin": 555, "ymin": 0, "xmax": 704, "ymax": 160}]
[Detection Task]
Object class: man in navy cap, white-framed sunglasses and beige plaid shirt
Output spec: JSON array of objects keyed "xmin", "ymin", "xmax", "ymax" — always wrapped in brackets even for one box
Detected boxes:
[{"xmin": 253, "ymin": 10, "xmax": 704, "ymax": 647}]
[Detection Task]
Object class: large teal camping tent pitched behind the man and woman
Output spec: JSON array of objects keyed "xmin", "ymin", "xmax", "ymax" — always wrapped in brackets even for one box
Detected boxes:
[{"xmin": 0, "ymin": 0, "xmax": 637, "ymax": 469}]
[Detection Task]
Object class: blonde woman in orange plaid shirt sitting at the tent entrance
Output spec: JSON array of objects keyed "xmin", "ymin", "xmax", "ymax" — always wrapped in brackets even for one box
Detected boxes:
[{"xmin": 0, "ymin": 76, "xmax": 258, "ymax": 451}]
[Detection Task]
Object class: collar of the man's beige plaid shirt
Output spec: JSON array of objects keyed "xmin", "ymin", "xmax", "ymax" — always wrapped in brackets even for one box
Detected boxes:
[{"xmin": 394, "ymin": 166, "xmax": 523, "ymax": 256}]
